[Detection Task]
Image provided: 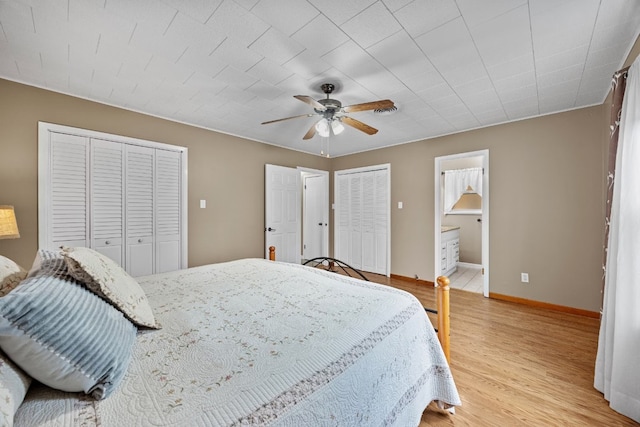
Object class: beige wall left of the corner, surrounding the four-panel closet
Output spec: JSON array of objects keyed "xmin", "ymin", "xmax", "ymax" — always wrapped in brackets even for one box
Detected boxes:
[{"xmin": 0, "ymin": 79, "xmax": 330, "ymax": 268}]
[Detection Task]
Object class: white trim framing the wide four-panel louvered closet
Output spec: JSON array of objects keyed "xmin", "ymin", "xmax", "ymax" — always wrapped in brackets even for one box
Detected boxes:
[{"xmin": 38, "ymin": 121, "xmax": 189, "ymax": 268}]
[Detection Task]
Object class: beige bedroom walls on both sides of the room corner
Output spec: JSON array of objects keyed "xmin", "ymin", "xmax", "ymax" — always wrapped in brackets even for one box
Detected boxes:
[{"xmin": 0, "ymin": 32, "xmax": 640, "ymax": 311}]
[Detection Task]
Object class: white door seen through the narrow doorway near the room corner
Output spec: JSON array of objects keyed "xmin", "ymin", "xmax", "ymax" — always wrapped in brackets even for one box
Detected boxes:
[{"xmin": 302, "ymin": 175, "xmax": 329, "ymax": 259}]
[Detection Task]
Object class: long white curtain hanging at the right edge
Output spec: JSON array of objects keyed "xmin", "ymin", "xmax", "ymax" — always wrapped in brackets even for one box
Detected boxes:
[{"xmin": 594, "ymin": 59, "xmax": 640, "ymax": 422}]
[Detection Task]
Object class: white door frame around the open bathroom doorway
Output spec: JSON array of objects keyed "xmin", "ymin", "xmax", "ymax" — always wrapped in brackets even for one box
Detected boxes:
[{"xmin": 433, "ymin": 149, "xmax": 489, "ymax": 297}]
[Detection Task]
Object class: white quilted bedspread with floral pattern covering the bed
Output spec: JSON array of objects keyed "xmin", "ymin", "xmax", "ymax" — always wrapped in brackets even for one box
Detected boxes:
[{"xmin": 16, "ymin": 259, "xmax": 460, "ymax": 427}]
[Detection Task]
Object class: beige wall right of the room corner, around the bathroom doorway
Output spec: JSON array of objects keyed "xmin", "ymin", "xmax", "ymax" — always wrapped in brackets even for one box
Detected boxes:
[{"xmin": 332, "ymin": 106, "xmax": 604, "ymax": 311}]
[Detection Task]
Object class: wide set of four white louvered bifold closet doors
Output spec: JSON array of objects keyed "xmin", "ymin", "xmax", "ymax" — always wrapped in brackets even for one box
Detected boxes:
[{"xmin": 38, "ymin": 123, "xmax": 186, "ymax": 276}]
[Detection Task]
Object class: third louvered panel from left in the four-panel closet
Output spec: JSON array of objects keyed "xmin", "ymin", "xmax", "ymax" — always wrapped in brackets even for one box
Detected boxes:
[{"xmin": 125, "ymin": 145, "xmax": 155, "ymax": 277}]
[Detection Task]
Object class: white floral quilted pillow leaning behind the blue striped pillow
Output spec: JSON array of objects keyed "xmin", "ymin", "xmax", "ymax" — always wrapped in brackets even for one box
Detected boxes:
[{"xmin": 62, "ymin": 247, "xmax": 160, "ymax": 329}]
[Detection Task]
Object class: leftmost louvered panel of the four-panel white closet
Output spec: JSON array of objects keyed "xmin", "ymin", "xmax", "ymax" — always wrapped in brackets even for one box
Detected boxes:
[{"xmin": 46, "ymin": 132, "xmax": 90, "ymax": 249}]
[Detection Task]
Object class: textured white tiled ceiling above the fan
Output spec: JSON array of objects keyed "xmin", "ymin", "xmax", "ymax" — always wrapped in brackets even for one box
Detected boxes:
[{"xmin": 0, "ymin": 0, "xmax": 640, "ymax": 156}]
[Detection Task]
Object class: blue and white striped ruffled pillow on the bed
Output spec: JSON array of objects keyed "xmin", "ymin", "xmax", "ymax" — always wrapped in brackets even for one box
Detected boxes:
[{"xmin": 0, "ymin": 259, "xmax": 137, "ymax": 399}]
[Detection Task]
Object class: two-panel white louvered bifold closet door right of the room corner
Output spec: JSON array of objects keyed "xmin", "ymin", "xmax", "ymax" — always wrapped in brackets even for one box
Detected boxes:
[{"xmin": 335, "ymin": 168, "xmax": 389, "ymax": 274}]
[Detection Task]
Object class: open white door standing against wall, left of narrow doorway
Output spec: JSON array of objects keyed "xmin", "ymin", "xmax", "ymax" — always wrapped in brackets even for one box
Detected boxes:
[{"xmin": 264, "ymin": 164, "xmax": 301, "ymax": 263}]
